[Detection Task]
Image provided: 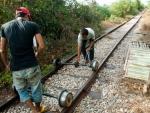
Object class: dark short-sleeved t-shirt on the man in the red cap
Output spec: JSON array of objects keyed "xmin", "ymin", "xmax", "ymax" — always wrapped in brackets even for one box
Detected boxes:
[{"xmin": 1, "ymin": 19, "xmax": 40, "ymax": 71}]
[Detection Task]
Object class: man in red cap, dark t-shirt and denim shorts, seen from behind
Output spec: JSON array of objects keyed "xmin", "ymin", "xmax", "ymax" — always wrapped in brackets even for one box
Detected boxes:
[{"xmin": 0, "ymin": 7, "xmax": 45, "ymax": 113}]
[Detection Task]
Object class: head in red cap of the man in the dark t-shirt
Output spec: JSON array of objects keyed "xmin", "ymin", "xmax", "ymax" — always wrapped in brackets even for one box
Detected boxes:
[{"xmin": 16, "ymin": 7, "xmax": 31, "ymax": 19}]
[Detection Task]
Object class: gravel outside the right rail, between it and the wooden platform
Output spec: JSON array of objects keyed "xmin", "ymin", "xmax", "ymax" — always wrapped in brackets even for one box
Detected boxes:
[{"xmin": 74, "ymin": 15, "xmax": 143, "ymax": 113}]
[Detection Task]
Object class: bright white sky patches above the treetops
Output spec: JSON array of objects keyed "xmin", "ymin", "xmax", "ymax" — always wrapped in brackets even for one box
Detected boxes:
[{"xmin": 77, "ymin": 0, "xmax": 150, "ymax": 5}]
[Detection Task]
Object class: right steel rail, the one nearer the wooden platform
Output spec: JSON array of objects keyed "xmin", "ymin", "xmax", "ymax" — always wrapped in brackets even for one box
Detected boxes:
[{"xmin": 61, "ymin": 16, "xmax": 142, "ymax": 113}]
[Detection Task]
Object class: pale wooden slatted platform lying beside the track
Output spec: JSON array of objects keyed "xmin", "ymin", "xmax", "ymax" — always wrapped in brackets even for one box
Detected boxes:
[{"xmin": 124, "ymin": 42, "xmax": 150, "ymax": 83}]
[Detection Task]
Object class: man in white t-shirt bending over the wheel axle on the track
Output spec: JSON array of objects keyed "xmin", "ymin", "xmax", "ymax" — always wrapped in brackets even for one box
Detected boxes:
[{"xmin": 77, "ymin": 28, "xmax": 95, "ymax": 63}]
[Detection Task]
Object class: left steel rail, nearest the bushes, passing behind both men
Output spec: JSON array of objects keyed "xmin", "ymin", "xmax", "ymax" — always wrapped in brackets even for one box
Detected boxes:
[{"xmin": 0, "ymin": 17, "xmax": 134, "ymax": 111}]
